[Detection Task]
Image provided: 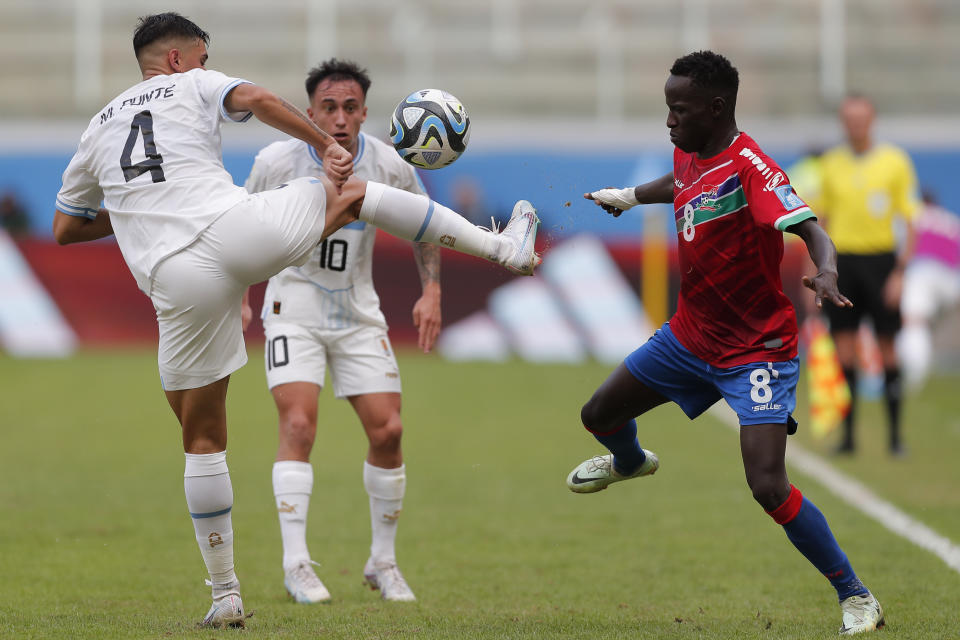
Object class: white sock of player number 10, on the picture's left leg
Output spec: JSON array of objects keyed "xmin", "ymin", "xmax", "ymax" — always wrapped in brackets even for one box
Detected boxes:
[{"xmin": 273, "ymin": 460, "xmax": 313, "ymax": 571}]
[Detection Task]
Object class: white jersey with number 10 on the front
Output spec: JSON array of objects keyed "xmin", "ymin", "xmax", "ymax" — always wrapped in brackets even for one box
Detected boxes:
[{"xmin": 246, "ymin": 133, "xmax": 426, "ymax": 329}]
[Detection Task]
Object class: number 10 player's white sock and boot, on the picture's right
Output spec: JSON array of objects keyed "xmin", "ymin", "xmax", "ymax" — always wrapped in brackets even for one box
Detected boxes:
[{"xmin": 363, "ymin": 462, "xmax": 417, "ymax": 602}]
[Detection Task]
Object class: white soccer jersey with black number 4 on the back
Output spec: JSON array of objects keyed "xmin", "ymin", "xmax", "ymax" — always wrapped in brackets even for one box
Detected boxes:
[{"xmin": 57, "ymin": 69, "xmax": 252, "ymax": 294}]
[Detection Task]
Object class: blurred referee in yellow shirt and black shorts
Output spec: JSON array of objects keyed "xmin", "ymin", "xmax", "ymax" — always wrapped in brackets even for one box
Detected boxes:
[{"xmin": 814, "ymin": 96, "xmax": 920, "ymax": 456}]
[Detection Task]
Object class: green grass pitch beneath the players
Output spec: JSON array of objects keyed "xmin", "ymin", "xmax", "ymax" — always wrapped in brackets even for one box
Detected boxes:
[{"xmin": 0, "ymin": 351, "xmax": 960, "ymax": 640}]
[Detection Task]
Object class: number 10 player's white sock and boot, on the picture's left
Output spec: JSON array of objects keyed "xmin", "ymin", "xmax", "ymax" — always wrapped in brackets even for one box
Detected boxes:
[{"xmin": 273, "ymin": 460, "xmax": 330, "ymax": 604}]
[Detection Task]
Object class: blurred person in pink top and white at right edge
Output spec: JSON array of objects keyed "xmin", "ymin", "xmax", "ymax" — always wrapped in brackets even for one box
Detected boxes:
[{"xmin": 897, "ymin": 192, "xmax": 960, "ymax": 388}]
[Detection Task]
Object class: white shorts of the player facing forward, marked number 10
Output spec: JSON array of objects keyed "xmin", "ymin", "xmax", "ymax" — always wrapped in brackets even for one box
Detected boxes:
[{"xmin": 264, "ymin": 321, "xmax": 400, "ymax": 398}]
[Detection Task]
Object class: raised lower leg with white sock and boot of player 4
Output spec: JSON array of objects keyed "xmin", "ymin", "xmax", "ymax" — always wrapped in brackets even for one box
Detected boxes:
[{"xmin": 359, "ymin": 182, "xmax": 541, "ymax": 275}]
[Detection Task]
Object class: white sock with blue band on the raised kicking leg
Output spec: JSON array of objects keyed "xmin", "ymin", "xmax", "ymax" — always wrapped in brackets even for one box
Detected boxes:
[{"xmin": 359, "ymin": 182, "xmax": 512, "ymax": 262}]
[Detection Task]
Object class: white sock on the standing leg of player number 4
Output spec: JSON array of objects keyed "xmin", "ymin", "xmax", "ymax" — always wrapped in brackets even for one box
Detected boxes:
[{"xmin": 183, "ymin": 451, "xmax": 238, "ymax": 598}]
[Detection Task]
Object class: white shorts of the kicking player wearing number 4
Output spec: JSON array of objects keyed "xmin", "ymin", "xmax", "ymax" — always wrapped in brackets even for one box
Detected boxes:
[{"xmin": 150, "ymin": 178, "xmax": 326, "ymax": 391}]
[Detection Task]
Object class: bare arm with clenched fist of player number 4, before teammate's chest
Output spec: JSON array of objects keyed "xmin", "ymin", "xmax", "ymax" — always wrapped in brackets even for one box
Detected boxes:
[{"xmin": 223, "ymin": 83, "xmax": 353, "ymax": 189}]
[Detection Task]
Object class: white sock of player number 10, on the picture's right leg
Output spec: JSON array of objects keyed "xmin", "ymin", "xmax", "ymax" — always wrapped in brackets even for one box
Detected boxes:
[{"xmin": 363, "ymin": 461, "xmax": 407, "ymax": 565}]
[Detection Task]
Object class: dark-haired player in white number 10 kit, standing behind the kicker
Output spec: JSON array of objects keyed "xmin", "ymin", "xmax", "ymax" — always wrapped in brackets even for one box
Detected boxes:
[{"xmin": 244, "ymin": 58, "xmax": 438, "ymax": 604}]
